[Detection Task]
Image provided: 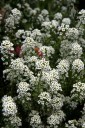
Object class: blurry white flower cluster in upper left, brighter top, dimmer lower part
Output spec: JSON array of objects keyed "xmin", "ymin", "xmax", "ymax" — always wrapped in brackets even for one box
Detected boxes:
[{"xmin": 5, "ymin": 8, "xmax": 22, "ymax": 31}]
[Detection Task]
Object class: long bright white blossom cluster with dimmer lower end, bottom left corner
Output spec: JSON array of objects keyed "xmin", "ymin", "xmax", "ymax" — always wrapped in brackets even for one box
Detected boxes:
[{"xmin": 2, "ymin": 95, "xmax": 22, "ymax": 128}]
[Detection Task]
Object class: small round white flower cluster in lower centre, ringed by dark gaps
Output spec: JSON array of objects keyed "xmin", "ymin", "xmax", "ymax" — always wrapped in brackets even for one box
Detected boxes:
[{"xmin": 38, "ymin": 92, "xmax": 51, "ymax": 106}]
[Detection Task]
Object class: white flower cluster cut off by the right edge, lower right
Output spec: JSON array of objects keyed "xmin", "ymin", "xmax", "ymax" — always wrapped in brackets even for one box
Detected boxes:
[{"xmin": 71, "ymin": 82, "xmax": 85, "ymax": 102}]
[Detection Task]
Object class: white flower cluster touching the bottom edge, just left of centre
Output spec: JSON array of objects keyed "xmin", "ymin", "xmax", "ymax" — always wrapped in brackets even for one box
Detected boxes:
[{"xmin": 29, "ymin": 110, "xmax": 42, "ymax": 128}]
